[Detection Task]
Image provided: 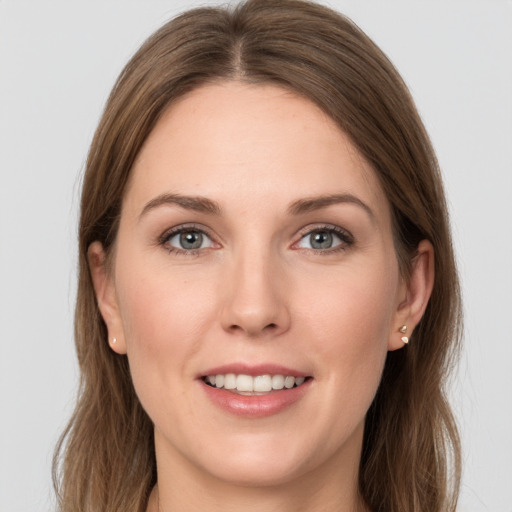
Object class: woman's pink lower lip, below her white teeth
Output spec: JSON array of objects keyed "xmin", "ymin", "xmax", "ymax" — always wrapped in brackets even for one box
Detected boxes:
[{"xmin": 200, "ymin": 379, "xmax": 312, "ymax": 418}]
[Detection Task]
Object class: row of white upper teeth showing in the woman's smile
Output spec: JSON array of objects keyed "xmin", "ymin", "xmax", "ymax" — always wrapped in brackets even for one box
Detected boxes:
[{"xmin": 204, "ymin": 373, "xmax": 306, "ymax": 393}]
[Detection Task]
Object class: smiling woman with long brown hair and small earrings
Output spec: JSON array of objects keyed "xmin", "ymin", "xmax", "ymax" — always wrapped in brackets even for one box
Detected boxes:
[{"xmin": 52, "ymin": 0, "xmax": 460, "ymax": 512}]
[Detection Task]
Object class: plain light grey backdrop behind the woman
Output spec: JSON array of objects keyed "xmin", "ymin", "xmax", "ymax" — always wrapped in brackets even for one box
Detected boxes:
[{"xmin": 0, "ymin": 0, "xmax": 512, "ymax": 512}]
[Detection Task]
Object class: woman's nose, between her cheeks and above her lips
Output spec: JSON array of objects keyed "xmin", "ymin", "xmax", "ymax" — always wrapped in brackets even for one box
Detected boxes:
[{"xmin": 221, "ymin": 246, "xmax": 290, "ymax": 338}]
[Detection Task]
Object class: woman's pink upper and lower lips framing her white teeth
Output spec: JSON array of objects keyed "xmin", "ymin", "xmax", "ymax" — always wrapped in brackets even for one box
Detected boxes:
[{"xmin": 198, "ymin": 364, "xmax": 313, "ymax": 419}]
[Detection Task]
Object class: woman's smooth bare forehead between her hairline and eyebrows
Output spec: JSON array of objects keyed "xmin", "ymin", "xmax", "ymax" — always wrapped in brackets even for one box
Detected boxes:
[{"xmin": 125, "ymin": 82, "xmax": 388, "ymax": 220}]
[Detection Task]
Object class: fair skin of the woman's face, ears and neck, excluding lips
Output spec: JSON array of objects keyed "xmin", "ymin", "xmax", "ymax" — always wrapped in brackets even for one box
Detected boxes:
[{"xmin": 89, "ymin": 82, "xmax": 433, "ymax": 512}]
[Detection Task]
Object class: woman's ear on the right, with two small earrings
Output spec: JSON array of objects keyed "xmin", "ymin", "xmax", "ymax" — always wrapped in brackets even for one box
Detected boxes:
[{"xmin": 388, "ymin": 240, "xmax": 435, "ymax": 350}]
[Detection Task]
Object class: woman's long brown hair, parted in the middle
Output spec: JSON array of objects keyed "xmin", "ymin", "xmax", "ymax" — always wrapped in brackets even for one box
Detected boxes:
[{"xmin": 54, "ymin": 0, "xmax": 461, "ymax": 512}]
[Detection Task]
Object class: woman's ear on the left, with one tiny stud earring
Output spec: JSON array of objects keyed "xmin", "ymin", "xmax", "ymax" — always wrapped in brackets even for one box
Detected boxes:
[{"xmin": 87, "ymin": 242, "xmax": 126, "ymax": 354}]
